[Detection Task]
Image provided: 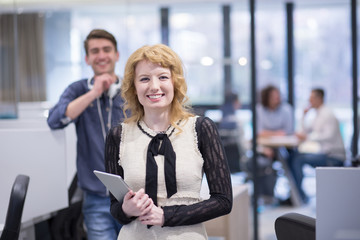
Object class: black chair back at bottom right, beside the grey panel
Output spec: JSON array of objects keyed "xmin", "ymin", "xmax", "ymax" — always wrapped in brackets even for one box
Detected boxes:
[{"xmin": 275, "ymin": 213, "xmax": 316, "ymax": 240}]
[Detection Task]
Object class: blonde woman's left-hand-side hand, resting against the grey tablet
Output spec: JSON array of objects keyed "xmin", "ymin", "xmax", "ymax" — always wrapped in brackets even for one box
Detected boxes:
[{"xmin": 122, "ymin": 188, "xmax": 154, "ymax": 217}]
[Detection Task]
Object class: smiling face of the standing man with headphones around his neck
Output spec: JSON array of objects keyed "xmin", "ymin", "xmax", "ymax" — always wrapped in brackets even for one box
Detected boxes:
[{"xmin": 85, "ymin": 38, "xmax": 119, "ymax": 75}]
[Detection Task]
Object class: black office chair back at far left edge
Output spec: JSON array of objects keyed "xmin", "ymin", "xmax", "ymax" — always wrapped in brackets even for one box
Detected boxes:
[{"xmin": 0, "ymin": 175, "xmax": 30, "ymax": 240}]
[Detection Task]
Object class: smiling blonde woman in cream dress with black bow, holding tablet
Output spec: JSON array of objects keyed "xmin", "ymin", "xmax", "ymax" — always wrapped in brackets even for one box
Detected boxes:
[{"xmin": 105, "ymin": 44, "xmax": 232, "ymax": 240}]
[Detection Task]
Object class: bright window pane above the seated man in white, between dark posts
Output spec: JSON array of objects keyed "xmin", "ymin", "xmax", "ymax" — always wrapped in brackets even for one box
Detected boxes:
[{"xmin": 294, "ymin": 4, "xmax": 353, "ymax": 149}]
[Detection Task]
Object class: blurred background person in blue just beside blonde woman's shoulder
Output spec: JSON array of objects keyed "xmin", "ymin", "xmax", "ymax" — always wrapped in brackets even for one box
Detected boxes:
[{"xmin": 219, "ymin": 92, "xmax": 245, "ymax": 173}]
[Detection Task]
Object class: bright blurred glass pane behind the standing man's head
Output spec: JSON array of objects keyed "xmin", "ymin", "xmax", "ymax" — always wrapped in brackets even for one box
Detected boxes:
[{"xmin": 45, "ymin": 4, "xmax": 160, "ymax": 103}]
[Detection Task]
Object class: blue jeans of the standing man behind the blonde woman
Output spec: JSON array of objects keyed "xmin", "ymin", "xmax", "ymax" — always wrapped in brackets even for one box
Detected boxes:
[{"xmin": 82, "ymin": 192, "xmax": 121, "ymax": 240}]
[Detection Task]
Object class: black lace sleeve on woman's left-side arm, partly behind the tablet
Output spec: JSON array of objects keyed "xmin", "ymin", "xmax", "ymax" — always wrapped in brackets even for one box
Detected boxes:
[{"xmin": 105, "ymin": 125, "xmax": 134, "ymax": 224}]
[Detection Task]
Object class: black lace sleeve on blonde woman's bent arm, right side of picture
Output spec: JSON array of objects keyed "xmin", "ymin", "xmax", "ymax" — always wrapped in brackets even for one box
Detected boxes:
[{"xmin": 163, "ymin": 117, "xmax": 233, "ymax": 226}]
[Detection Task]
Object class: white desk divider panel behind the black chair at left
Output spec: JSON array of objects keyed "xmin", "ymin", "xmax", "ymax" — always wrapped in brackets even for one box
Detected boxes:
[{"xmin": 0, "ymin": 122, "xmax": 75, "ymax": 240}]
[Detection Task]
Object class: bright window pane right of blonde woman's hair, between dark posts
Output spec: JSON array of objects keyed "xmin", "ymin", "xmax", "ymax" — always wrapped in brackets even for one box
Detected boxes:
[{"xmin": 169, "ymin": 3, "xmax": 224, "ymax": 105}]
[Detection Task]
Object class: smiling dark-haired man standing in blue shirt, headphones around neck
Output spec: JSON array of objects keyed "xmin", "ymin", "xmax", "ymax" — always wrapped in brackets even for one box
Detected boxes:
[{"xmin": 47, "ymin": 29, "xmax": 124, "ymax": 240}]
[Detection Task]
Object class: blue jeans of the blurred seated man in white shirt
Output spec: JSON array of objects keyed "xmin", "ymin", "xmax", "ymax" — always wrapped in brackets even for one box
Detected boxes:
[{"xmin": 289, "ymin": 153, "xmax": 344, "ymax": 202}]
